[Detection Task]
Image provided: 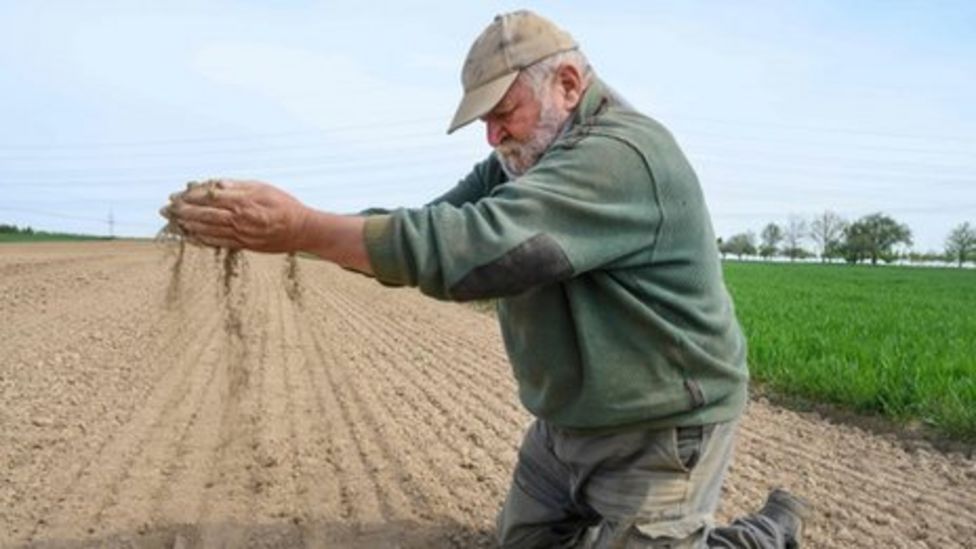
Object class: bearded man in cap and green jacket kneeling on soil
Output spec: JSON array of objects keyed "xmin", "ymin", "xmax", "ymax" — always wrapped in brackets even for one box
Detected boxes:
[{"xmin": 163, "ymin": 11, "xmax": 808, "ymax": 547}]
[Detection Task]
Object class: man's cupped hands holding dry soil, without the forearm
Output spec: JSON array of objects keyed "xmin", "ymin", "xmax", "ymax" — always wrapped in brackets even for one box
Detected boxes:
[{"xmin": 161, "ymin": 179, "xmax": 310, "ymax": 253}]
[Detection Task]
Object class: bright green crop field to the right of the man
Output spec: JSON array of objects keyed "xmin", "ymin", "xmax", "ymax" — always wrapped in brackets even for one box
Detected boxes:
[{"xmin": 725, "ymin": 262, "xmax": 976, "ymax": 440}]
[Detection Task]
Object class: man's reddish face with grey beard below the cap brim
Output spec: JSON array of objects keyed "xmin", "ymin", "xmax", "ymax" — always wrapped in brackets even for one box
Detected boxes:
[{"xmin": 481, "ymin": 78, "xmax": 568, "ymax": 179}]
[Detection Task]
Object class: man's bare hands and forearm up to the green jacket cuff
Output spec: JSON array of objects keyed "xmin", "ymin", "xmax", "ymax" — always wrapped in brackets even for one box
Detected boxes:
[{"xmin": 160, "ymin": 179, "xmax": 373, "ymax": 274}]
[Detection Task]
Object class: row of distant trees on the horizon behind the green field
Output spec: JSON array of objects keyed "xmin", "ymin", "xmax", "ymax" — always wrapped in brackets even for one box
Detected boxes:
[{"xmin": 718, "ymin": 210, "xmax": 976, "ymax": 267}]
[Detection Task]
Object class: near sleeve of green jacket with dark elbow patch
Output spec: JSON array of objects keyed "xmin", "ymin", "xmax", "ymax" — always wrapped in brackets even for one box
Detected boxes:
[{"xmin": 365, "ymin": 136, "xmax": 661, "ymax": 301}]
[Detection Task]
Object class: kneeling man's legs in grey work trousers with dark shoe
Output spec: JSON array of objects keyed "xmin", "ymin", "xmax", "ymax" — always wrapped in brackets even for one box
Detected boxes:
[{"xmin": 498, "ymin": 420, "xmax": 785, "ymax": 549}]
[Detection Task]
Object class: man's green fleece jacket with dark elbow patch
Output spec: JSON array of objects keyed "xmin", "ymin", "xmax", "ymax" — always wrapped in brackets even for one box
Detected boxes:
[{"xmin": 365, "ymin": 81, "xmax": 748, "ymax": 432}]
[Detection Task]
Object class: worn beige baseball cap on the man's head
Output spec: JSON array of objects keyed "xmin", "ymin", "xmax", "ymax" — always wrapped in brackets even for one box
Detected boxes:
[{"xmin": 447, "ymin": 10, "xmax": 578, "ymax": 133}]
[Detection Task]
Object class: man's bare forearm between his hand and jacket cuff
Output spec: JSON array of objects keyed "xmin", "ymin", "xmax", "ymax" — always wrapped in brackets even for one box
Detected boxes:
[{"xmin": 299, "ymin": 208, "xmax": 373, "ymax": 275}]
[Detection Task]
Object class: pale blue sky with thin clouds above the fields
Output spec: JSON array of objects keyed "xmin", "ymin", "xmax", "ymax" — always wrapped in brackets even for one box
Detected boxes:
[{"xmin": 0, "ymin": 0, "xmax": 976, "ymax": 250}]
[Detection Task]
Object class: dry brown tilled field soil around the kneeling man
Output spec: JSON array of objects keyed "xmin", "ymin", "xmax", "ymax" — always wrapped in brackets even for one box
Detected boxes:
[{"xmin": 0, "ymin": 243, "xmax": 976, "ymax": 548}]
